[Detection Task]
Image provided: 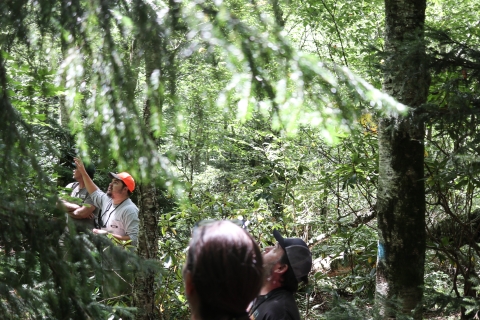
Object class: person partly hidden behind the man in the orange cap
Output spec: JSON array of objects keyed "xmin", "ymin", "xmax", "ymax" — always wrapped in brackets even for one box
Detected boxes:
[{"xmin": 61, "ymin": 165, "xmax": 98, "ymax": 231}]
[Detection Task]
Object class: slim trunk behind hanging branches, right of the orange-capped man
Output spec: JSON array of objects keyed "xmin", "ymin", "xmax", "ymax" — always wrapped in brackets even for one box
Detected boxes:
[{"xmin": 132, "ymin": 0, "xmax": 181, "ymax": 320}]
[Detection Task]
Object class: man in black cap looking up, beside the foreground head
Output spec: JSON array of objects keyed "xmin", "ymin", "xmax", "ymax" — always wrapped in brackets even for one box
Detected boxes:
[{"xmin": 249, "ymin": 230, "xmax": 312, "ymax": 320}]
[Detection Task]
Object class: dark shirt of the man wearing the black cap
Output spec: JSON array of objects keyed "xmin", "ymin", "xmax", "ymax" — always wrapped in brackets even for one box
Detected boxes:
[{"xmin": 250, "ymin": 287, "xmax": 300, "ymax": 320}]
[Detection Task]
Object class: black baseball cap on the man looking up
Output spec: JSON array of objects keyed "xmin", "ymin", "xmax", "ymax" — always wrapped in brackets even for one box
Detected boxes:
[{"xmin": 273, "ymin": 230, "xmax": 312, "ymax": 283}]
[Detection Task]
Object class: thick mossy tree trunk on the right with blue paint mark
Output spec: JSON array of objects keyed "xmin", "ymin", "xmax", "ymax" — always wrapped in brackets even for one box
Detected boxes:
[{"xmin": 376, "ymin": 0, "xmax": 429, "ymax": 319}]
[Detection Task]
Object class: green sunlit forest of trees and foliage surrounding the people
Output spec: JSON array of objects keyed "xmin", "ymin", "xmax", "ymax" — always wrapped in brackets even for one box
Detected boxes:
[{"xmin": 0, "ymin": 0, "xmax": 480, "ymax": 320}]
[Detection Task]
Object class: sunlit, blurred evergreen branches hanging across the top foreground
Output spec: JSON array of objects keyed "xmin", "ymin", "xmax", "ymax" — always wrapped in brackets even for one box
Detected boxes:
[{"xmin": 6, "ymin": 0, "xmax": 405, "ymax": 179}]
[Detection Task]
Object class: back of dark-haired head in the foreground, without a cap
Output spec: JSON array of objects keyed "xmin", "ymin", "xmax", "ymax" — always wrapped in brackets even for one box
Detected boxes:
[{"xmin": 183, "ymin": 220, "xmax": 263, "ymax": 320}]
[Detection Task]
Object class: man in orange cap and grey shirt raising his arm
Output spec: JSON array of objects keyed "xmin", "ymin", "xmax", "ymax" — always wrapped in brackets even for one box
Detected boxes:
[{"xmin": 74, "ymin": 158, "xmax": 139, "ymax": 246}]
